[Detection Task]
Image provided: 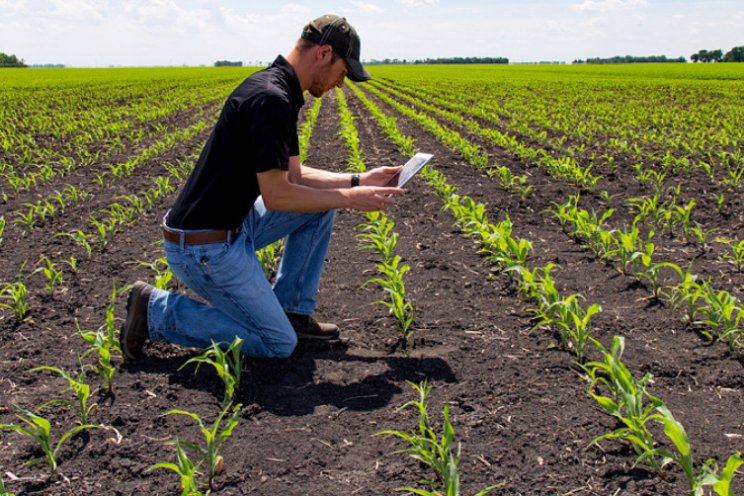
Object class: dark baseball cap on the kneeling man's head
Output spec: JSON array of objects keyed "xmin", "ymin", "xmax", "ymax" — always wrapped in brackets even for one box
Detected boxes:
[{"xmin": 302, "ymin": 14, "xmax": 372, "ymax": 82}]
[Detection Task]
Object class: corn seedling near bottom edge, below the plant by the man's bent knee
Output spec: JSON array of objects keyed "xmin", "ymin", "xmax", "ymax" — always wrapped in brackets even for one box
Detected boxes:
[{"xmin": 163, "ymin": 404, "xmax": 243, "ymax": 490}]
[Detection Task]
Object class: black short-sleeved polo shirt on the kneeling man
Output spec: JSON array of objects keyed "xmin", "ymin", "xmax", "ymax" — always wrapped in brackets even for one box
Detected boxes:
[{"xmin": 168, "ymin": 55, "xmax": 305, "ymax": 229}]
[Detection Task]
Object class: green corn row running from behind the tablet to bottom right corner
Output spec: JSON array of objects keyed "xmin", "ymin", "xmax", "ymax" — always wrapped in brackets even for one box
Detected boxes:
[{"xmin": 346, "ymin": 79, "xmax": 742, "ymax": 495}]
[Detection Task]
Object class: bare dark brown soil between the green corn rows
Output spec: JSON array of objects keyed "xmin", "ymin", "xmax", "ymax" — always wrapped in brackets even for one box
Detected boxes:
[{"xmin": 0, "ymin": 81, "xmax": 744, "ymax": 496}]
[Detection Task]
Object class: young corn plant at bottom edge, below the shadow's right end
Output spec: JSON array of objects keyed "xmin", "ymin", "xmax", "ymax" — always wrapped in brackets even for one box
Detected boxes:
[{"xmin": 375, "ymin": 381, "xmax": 498, "ymax": 496}]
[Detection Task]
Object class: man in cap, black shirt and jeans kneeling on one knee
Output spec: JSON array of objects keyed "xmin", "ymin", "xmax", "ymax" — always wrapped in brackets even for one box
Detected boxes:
[{"xmin": 120, "ymin": 15, "xmax": 403, "ymax": 359}]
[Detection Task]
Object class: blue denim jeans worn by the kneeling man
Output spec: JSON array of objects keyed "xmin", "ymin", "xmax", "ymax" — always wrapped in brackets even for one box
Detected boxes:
[{"xmin": 147, "ymin": 197, "xmax": 336, "ymax": 358}]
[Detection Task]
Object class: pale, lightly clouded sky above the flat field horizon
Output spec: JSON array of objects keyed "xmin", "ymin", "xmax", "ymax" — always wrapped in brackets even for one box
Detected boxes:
[{"xmin": 0, "ymin": 0, "xmax": 744, "ymax": 67}]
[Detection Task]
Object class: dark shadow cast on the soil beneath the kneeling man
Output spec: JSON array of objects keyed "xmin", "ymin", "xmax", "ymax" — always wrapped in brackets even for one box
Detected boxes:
[{"xmin": 124, "ymin": 343, "xmax": 457, "ymax": 417}]
